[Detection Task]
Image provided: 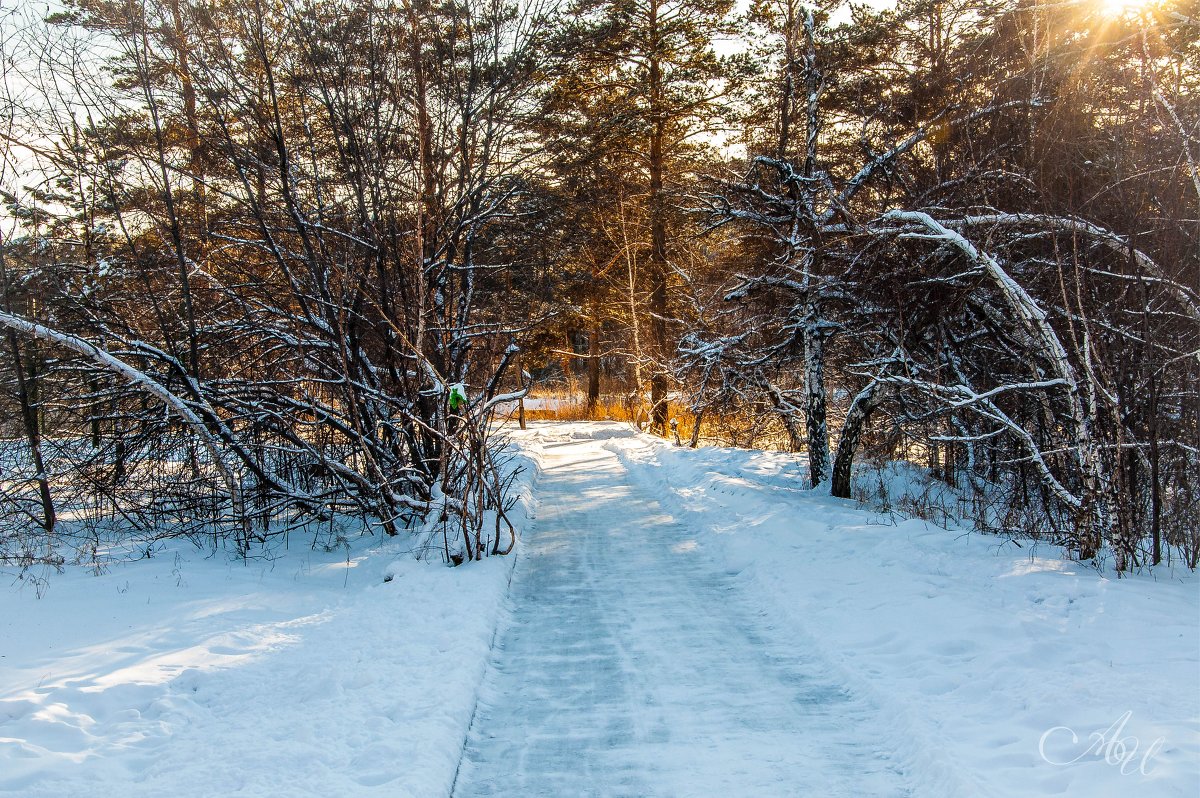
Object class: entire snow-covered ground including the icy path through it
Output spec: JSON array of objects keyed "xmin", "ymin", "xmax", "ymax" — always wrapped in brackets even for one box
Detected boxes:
[{"xmin": 0, "ymin": 424, "xmax": 1200, "ymax": 798}]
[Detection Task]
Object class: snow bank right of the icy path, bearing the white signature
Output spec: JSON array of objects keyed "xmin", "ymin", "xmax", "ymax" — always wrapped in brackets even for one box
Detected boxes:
[{"xmin": 607, "ymin": 422, "xmax": 1200, "ymax": 798}]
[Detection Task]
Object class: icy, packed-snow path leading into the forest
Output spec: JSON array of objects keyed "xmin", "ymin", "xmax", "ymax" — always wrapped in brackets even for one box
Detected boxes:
[{"xmin": 454, "ymin": 429, "xmax": 908, "ymax": 798}]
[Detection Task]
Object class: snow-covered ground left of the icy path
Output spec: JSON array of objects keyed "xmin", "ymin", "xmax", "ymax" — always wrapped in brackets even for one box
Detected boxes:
[{"xmin": 0, "ymin": 441, "xmax": 536, "ymax": 798}]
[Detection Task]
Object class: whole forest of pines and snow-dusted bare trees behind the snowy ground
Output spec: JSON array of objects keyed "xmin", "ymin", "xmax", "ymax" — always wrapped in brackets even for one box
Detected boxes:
[{"xmin": 0, "ymin": 0, "xmax": 1200, "ymax": 571}]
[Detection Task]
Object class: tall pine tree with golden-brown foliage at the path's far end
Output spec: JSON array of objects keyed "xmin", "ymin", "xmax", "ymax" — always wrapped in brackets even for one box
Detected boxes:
[{"xmin": 551, "ymin": 0, "xmax": 748, "ymax": 434}]
